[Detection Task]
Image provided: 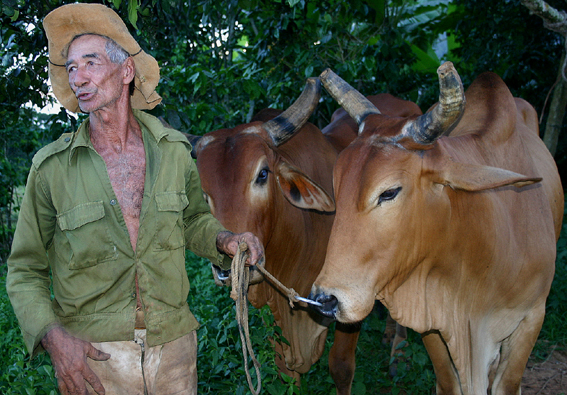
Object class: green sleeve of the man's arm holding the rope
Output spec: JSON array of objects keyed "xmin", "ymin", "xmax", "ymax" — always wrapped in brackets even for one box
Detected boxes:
[{"xmin": 183, "ymin": 157, "xmax": 231, "ymax": 269}]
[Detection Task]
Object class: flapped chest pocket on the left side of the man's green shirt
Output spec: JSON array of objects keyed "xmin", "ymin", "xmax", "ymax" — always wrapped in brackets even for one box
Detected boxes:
[{"xmin": 57, "ymin": 201, "xmax": 118, "ymax": 269}]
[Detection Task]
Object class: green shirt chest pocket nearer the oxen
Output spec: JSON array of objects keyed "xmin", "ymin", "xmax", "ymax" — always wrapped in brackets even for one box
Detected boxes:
[{"xmin": 156, "ymin": 191, "xmax": 189, "ymax": 250}]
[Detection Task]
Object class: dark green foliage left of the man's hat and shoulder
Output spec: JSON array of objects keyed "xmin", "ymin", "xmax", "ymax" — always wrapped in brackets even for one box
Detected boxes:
[{"xmin": 0, "ymin": 0, "xmax": 79, "ymax": 265}]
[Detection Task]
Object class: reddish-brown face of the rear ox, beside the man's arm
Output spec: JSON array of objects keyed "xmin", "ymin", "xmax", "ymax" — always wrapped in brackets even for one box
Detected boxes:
[{"xmin": 197, "ymin": 127, "xmax": 277, "ymax": 243}]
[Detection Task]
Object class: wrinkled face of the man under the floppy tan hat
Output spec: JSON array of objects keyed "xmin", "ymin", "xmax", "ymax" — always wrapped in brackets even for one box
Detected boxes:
[{"xmin": 65, "ymin": 35, "xmax": 128, "ymax": 113}]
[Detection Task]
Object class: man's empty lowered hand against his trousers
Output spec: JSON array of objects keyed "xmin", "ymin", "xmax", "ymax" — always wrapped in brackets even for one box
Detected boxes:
[{"xmin": 41, "ymin": 327, "xmax": 110, "ymax": 395}]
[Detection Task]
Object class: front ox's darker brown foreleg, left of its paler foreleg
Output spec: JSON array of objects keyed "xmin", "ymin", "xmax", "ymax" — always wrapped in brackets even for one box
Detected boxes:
[{"xmin": 421, "ymin": 331, "xmax": 462, "ymax": 395}]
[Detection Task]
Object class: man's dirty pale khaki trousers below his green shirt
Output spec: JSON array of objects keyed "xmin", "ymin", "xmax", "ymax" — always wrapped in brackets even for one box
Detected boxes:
[{"xmin": 87, "ymin": 329, "xmax": 197, "ymax": 395}]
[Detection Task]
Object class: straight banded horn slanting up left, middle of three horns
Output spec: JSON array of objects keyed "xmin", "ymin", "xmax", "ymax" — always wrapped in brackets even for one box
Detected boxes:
[{"xmin": 319, "ymin": 69, "xmax": 380, "ymax": 125}]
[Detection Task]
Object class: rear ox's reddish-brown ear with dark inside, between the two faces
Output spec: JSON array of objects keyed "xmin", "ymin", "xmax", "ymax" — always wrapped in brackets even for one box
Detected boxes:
[{"xmin": 276, "ymin": 161, "xmax": 335, "ymax": 212}]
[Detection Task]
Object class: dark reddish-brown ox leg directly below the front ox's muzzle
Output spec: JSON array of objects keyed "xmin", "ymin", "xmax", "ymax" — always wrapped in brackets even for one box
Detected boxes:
[{"xmin": 329, "ymin": 322, "xmax": 361, "ymax": 395}]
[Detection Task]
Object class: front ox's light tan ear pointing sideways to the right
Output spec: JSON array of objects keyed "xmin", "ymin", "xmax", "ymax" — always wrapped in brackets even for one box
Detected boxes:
[{"xmin": 441, "ymin": 161, "xmax": 542, "ymax": 191}]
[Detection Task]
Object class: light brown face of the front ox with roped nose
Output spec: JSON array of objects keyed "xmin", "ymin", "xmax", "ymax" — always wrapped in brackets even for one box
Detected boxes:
[{"xmin": 312, "ymin": 139, "xmax": 448, "ymax": 322}]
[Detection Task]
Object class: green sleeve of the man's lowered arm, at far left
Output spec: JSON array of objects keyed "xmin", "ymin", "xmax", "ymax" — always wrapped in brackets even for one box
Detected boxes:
[{"xmin": 6, "ymin": 166, "xmax": 58, "ymax": 356}]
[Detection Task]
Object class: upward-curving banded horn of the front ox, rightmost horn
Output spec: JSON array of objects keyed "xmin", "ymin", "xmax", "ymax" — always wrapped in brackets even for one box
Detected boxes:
[{"xmin": 405, "ymin": 62, "xmax": 465, "ymax": 144}]
